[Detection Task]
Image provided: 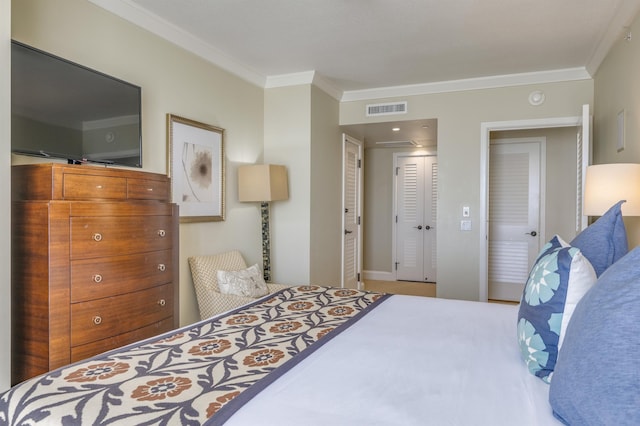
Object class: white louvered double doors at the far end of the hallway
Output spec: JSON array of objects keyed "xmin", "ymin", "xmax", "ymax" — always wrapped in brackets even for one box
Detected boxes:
[{"xmin": 396, "ymin": 156, "xmax": 438, "ymax": 282}]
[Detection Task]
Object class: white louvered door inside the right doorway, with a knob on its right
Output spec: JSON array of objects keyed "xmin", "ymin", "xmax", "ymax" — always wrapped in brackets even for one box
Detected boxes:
[{"xmin": 488, "ymin": 138, "xmax": 544, "ymax": 301}]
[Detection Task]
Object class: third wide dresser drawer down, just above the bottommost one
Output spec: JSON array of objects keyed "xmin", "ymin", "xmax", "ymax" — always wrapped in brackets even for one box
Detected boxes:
[{"xmin": 71, "ymin": 284, "xmax": 173, "ymax": 346}]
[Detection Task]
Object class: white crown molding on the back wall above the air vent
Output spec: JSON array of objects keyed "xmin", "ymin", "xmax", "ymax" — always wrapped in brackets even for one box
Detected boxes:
[{"xmin": 340, "ymin": 67, "xmax": 592, "ymax": 102}]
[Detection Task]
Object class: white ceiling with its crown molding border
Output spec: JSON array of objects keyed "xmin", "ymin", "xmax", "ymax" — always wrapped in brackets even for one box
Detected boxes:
[{"xmin": 91, "ymin": 0, "xmax": 640, "ymax": 145}]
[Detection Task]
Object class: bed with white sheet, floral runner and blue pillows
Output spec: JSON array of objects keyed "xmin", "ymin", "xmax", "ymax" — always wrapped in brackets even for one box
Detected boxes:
[{"xmin": 0, "ymin": 204, "xmax": 640, "ymax": 426}]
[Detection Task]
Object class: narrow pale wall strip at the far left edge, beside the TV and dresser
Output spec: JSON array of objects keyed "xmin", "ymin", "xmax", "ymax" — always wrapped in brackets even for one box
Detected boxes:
[{"xmin": 0, "ymin": 0, "xmax": 11, "ymax": 392}]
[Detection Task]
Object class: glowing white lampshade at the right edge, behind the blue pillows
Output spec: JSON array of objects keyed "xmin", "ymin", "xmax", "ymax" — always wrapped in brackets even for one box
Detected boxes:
[{"xmin": 584, "ymin": 163, "xmax": 640, "ymax": 216}]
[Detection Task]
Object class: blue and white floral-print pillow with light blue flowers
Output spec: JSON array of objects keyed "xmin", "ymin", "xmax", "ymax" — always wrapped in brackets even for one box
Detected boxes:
[{"xmin": 518, "ymin": 235, "xmax": 597, "ymax": 383}]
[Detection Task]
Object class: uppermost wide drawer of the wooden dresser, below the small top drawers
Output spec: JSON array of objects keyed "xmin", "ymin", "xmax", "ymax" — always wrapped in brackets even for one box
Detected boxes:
[{"xmin": 70, "ymin": 216, "xmax": 173, "ymax": 260}]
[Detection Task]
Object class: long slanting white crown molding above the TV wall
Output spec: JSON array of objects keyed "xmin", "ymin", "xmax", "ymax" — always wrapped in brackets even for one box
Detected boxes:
[{"xmin": 89, "ymin": 0, "xmax": 266, "ymax": 87}]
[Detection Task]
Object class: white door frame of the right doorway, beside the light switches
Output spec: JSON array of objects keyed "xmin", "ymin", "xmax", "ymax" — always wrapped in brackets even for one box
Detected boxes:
[{"xmin": 478, "ymin": 110, "xmax": 591, "ymax": 302}]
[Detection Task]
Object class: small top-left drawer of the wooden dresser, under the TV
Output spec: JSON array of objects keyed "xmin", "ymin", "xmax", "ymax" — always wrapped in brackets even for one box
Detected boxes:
[{"xmin": 62, "ymin": 173, "xmax": 127, "ymax": 200}]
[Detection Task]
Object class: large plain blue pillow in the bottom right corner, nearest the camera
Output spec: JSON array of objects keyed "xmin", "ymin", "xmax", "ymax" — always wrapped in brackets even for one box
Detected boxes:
[{"xmin": 549, "ymin": 247, "xmax": 640, "ymax": 426}]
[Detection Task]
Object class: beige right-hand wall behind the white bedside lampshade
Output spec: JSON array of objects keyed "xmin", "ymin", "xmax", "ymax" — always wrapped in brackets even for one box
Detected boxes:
[{"xmin": 593, "ymin": 10, "xmax": 640, "ymax": 247}]
